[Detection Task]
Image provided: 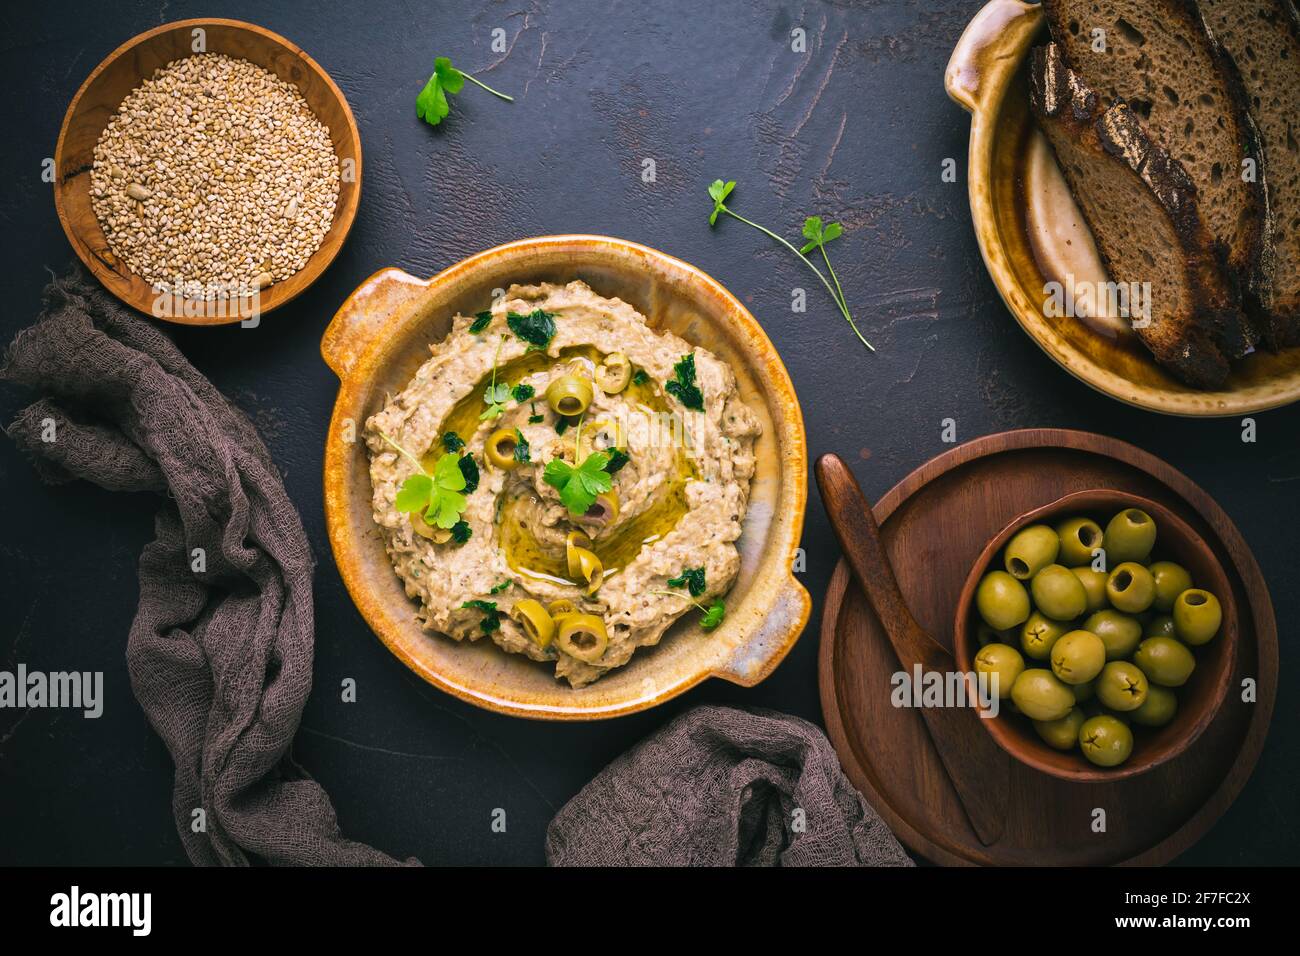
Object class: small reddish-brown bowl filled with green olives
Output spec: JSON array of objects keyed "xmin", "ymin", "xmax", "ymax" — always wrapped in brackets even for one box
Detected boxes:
[{"xmin": 953, "ymin": 489, "xmax": 1238, "ymax": 782}]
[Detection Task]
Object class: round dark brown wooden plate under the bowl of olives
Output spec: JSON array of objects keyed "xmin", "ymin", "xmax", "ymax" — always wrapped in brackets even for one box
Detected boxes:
[{"xmin": 819, "ymin": 428, "xmax": 1278, "ymax": 865}]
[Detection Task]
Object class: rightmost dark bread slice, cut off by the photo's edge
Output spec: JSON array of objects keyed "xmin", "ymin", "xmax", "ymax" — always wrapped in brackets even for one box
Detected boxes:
[{"xmin": 1200, "ymin": 0, "xmax": 1300, "ymax": 349}]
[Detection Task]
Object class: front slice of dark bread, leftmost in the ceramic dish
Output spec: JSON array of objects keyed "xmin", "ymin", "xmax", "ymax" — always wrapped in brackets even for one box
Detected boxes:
[{"xmin": 1030, "ymin": 43, "xmax": 1232, "ymax": 388}]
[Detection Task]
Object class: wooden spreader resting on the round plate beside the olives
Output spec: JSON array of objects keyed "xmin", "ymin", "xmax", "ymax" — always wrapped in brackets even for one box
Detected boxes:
[{"xmin": 815, "ymin": 455, "xmax": 1010, "ymax": 847}]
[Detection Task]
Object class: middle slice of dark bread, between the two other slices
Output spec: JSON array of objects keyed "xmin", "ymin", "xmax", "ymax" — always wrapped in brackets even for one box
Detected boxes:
[{"xmin": 1043, "ymin": 0, "xmax": 1269, "ymax": 358}]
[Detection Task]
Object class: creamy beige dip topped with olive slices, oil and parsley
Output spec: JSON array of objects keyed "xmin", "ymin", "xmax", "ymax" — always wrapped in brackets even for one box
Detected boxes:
[{"xmin": 365, "ymin": 282, "xmax": 762, "ymax": 687}]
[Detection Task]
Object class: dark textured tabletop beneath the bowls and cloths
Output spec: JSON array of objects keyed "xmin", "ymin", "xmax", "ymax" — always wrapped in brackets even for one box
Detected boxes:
[{"xmin": 0, "ymin": 0, "xmax": 1300, "ymax": 864}]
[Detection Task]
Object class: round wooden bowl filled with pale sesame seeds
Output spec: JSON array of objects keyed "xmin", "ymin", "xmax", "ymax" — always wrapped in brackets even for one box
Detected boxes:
[{"xmin": 55, "ymin": 18, "xmax": 361, "ymax": 325}]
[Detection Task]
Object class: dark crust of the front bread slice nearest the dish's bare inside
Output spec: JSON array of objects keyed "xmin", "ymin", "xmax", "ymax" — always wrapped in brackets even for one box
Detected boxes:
[{"xmin": 1030, "ymin": 43, "xmax": 1238, "ymax": 388}]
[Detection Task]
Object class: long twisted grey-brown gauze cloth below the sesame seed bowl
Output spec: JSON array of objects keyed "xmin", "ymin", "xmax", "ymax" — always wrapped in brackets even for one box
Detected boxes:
[{"xmin": 0, "ymin": 276, "xmax": 405, "ymax": 865}]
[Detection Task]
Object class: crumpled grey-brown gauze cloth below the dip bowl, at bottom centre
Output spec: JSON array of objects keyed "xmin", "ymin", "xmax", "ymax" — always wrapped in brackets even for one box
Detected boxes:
[{"xmin": 546, "ymin": 706, "xmax": 913, "ymax": 866}]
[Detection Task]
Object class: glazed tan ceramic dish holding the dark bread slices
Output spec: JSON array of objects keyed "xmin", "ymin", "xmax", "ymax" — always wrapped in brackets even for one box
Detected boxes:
[{"xmin": 944, "ymin": 0, "xmax": 1300, "ymax": 416}]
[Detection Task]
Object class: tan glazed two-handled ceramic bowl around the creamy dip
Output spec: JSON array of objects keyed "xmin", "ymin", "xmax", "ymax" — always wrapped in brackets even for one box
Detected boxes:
[{"xmin": 321, "ymin": 235, "xmax": 811, "ymax": 721}]
